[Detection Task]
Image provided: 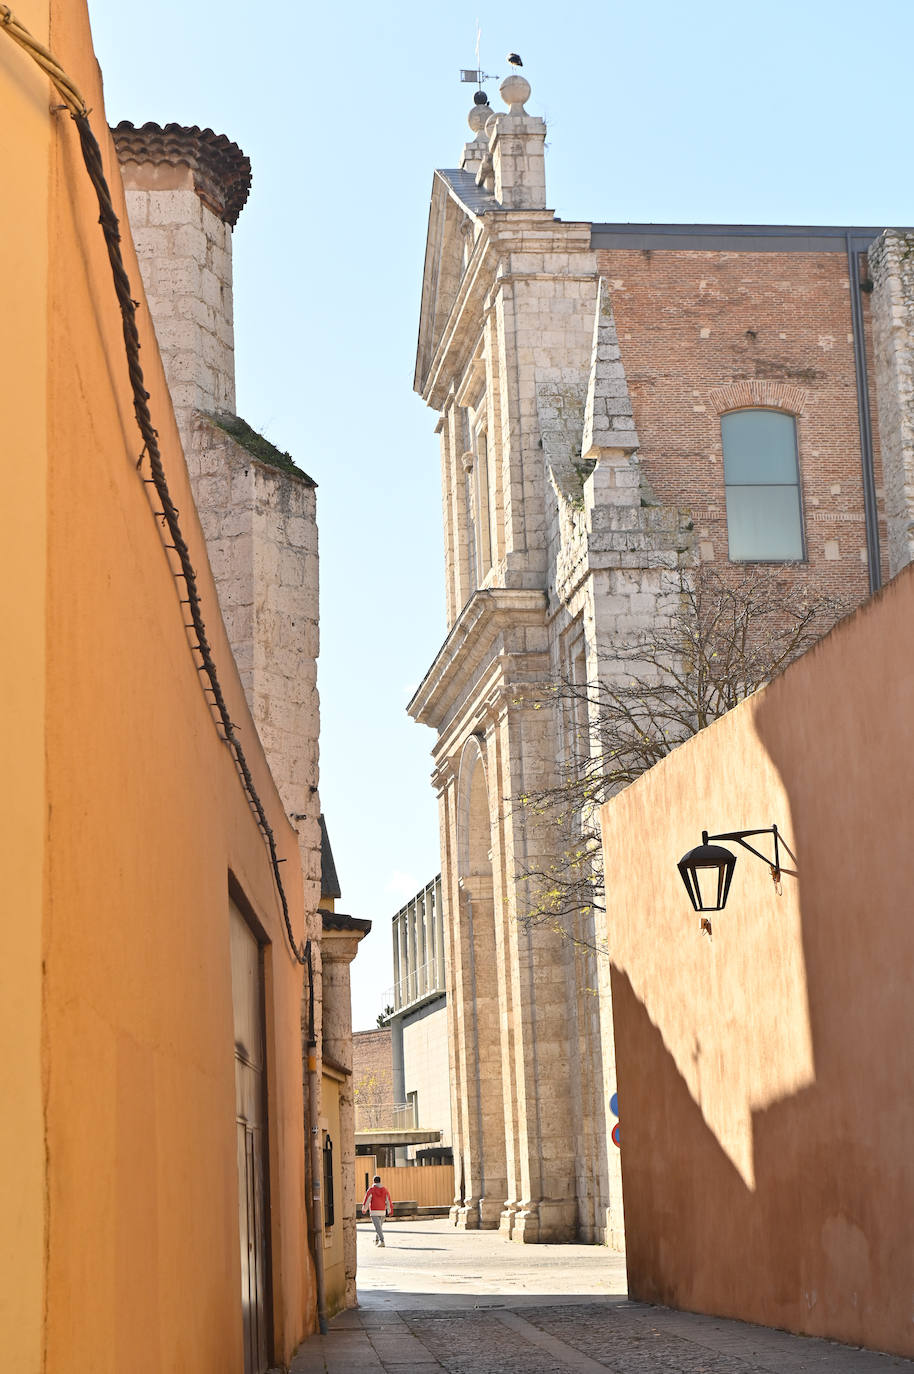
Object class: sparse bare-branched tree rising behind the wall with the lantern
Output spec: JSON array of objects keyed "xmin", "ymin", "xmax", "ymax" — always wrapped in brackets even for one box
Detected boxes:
[{"xmin": 513, "ymin": 567, "xmax": 849, "ymax": 943}]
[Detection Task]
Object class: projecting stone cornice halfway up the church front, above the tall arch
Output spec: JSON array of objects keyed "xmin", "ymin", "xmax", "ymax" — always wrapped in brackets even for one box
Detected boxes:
[{"xmin": 407, "ymin": 587, "xmax": 546, "ymax": 730}]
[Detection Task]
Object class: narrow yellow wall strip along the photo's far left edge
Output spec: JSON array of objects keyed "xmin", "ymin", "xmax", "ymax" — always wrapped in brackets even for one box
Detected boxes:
[{"xmin": 0, "ymin": 0, "xmax": 51, "ymax": 1374}]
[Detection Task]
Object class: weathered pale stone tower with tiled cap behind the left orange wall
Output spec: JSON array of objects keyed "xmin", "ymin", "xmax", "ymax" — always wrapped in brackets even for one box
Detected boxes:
[{"xmin": 113, "ymin": 121, "xmax": 320, "ymax": 917}]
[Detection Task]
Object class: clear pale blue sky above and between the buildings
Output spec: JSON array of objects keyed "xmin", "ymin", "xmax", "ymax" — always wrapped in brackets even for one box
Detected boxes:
[{"xmin": 88, "ymin": 0, "xmax": 914, "ymax": 1031}]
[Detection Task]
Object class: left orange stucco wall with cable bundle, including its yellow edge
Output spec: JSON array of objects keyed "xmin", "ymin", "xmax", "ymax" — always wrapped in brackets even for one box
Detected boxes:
[{"xmin": 0, "ymin": 0, "xmax": 313, "ymax": 1374}]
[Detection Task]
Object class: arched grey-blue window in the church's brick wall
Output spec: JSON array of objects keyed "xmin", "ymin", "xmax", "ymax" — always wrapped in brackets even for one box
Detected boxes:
[{"xmin": 720, "ymin": 411, "xmax": 805, "ymax": 563}]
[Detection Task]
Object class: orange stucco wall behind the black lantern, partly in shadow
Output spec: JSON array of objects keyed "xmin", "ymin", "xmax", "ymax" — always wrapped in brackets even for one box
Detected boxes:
[{"xmin": 602, "ymin": 570, "xmax": 914, "ymax": 1356}]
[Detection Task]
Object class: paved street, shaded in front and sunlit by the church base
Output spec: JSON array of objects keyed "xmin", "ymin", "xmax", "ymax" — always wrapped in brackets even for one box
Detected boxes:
[{"xmin": 291, "ymin": 1220, "xmax": 914, "ymax": 1374}]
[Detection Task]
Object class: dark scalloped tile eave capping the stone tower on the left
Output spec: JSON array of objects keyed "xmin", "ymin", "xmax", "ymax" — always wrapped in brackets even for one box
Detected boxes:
[{"xmin": 111, "ymin": 120, "xmax": 250, "ymax": 225}]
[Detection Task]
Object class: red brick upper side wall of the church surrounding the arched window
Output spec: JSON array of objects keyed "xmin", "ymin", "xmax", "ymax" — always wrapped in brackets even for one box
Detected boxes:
[{"xmin": 598, "ymin": 249, "xmax": 885, "ymax": 600}]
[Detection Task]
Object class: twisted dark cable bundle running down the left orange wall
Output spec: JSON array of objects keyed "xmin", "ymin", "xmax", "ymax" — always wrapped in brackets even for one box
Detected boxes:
[{"xmin": 0, "ymin": 4, "xmax": 313, "ymax": 978}]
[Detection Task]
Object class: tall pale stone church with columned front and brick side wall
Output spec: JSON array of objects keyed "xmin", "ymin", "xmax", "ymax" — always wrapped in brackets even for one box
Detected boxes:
[{"xmin": 408, "ymin": 76, "xmax": 911, "ymax": 1243}]
